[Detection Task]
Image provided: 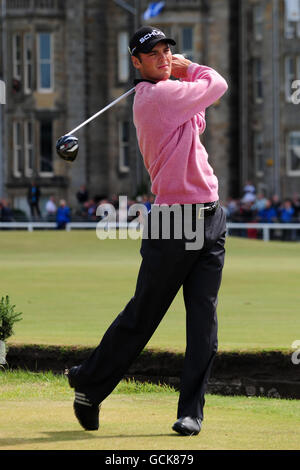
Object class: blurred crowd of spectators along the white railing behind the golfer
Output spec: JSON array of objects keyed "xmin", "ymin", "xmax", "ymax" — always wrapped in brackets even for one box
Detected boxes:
[{"xmin": 0, "ymin": 182, "xmax": 300, "ymax": 240}]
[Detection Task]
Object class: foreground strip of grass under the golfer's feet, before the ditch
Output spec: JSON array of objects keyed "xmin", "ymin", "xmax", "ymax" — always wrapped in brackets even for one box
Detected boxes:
[{"xmin": 0, "ymin": 371, "xmax": 300, "ymax": 451}]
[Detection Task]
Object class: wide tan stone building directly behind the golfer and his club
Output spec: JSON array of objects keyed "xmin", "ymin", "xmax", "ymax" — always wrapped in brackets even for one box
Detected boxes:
[{"xmin": 0, "ymin": 0, "xmax": 240, "ymax": 217}]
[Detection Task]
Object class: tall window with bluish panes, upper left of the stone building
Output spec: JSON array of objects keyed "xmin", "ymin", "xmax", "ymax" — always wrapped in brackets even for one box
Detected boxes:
[{"xmin": 37, "ymin": 33, "xmax": 53, "ymax": 92}]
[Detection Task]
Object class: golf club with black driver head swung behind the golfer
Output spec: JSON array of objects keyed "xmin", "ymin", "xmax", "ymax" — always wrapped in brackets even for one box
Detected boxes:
[{"xmin": 56, "ymin": 88, "xmax": 135, "ymax": 162}]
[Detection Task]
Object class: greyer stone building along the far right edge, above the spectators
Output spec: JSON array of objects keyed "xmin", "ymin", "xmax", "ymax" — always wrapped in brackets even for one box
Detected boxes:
[{"xmin": 240, "ymin": 0, "xmax": 300, "ymax": 198}]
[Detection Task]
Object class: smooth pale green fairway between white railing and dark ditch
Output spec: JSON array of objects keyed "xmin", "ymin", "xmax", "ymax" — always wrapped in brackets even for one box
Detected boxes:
[{"xmin": 0, "ymin": 230, "xmax": 300, "ymax": 352}]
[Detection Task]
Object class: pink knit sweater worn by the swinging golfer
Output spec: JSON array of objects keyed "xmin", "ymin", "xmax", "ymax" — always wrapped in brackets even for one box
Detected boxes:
[{"xmin": 133, "ymin": 63, "xmax": 228, "ymax": 205}]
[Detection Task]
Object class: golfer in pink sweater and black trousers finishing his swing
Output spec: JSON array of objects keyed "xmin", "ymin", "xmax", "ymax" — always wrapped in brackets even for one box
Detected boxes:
[{"xmin": 66, "ymin": 26, "xmax": 228, "ymax": 435}]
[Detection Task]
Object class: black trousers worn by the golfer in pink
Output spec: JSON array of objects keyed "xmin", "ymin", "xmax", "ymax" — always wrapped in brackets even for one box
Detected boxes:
[{"xmin": 75, "ymin": 207, "xmax": 226, "ymax": 419}]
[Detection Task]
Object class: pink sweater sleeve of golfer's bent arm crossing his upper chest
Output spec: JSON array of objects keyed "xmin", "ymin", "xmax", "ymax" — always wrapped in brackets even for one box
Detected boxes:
[{"xmin": 155, "ymin": 63, "xmax": 228, "ymax": 127}]
